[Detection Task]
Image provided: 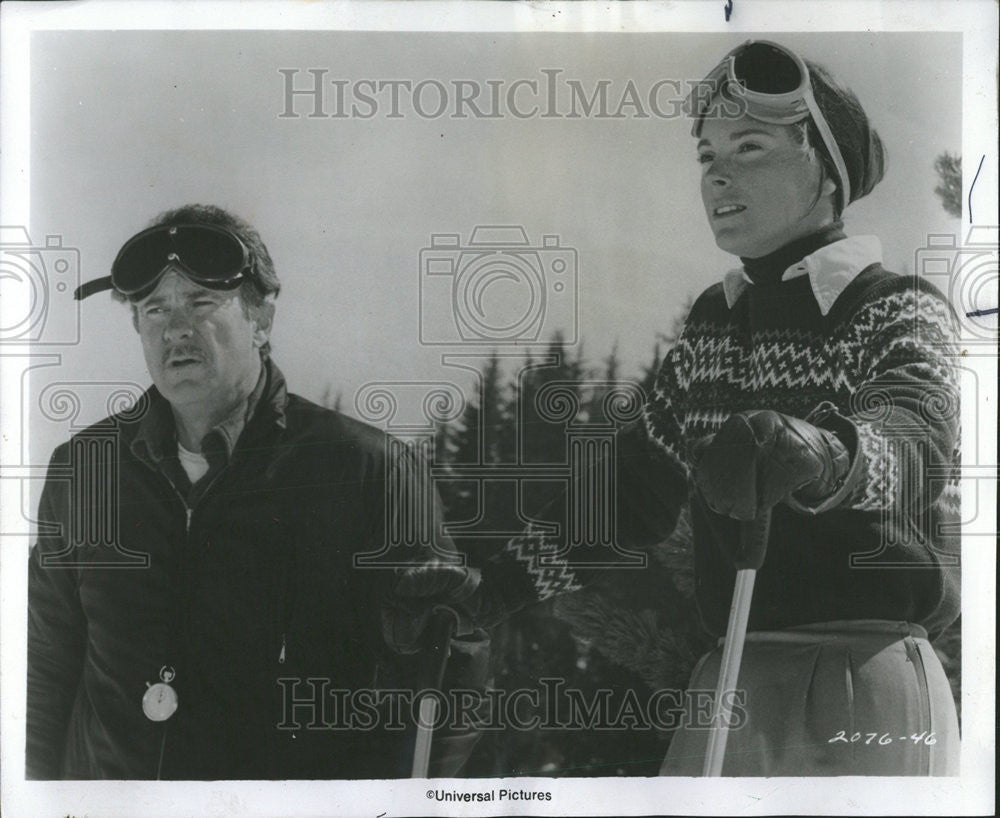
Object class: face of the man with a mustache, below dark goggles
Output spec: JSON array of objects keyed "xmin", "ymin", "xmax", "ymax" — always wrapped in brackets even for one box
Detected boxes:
[{"xmin": 135, "ymin": 270, "xmax": 270, "ymax": 415}]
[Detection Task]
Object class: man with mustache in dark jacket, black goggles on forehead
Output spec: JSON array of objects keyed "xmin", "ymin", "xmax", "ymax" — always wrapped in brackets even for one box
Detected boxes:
[{"xmin": 27, "ymin": 205, "xmax": 476, "ymax": 780}]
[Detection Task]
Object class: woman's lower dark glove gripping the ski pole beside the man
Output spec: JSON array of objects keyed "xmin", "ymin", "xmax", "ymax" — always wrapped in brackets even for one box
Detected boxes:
[{"xmin": 381, "ymin": 563, "xmax": 481, "ymax": 654}]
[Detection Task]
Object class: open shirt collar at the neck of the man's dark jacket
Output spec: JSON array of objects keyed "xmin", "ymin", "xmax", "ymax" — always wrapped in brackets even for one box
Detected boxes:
[{"xmin": 130, "ymin": 358, "xmax": 288, "ymax": 463}]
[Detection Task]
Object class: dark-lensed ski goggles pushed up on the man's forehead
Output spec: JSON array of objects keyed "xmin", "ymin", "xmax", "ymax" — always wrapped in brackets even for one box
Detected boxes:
[{"xmin": 74, "ymin": 224, "xmax": 253, "ymax": 301}]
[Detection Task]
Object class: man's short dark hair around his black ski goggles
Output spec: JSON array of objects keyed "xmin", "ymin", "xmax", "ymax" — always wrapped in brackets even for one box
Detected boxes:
[{"xmin": 117, "ymin": 204, "xmax": 281, "ymax": 359}]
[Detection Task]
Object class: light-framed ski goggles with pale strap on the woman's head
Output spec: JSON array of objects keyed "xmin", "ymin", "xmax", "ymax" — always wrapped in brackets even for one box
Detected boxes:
[{"xmin": 684, "ymin": 40, "xmax": 851, "ymax": 207}]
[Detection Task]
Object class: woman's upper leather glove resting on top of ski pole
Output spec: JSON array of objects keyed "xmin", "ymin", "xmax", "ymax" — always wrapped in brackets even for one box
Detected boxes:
[{"xmin": 691, "ymin": 409, "xmax": 851, "ymax": 520}]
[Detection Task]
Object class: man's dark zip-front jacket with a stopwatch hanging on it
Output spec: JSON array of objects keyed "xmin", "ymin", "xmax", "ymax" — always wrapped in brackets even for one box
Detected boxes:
[{"xmin": 27, "ymin": 362, "xmax": 458, "ymax": 779}]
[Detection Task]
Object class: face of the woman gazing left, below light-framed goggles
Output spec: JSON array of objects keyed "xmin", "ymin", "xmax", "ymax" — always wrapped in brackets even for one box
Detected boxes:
[{"xmin": 698, "ymin": 116, "xmax": 836, "ymax": 258}]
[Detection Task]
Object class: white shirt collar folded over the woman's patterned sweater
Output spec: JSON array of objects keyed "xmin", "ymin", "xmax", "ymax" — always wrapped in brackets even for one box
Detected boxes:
[{"xmin": 722, "ymin": 236, "xmax": 882, "ymax": 315}]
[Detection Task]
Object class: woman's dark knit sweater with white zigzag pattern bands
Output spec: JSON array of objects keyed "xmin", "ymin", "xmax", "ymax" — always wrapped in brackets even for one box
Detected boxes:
[{"xmin": 484, "ymin": 237, "xmax": 960, "ymax": 636}]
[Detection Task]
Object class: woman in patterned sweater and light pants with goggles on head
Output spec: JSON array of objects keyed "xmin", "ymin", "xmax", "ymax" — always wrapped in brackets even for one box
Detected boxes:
[{"xmin": 645, "ymin": 41, "xmax": 960, "ymax": 776}]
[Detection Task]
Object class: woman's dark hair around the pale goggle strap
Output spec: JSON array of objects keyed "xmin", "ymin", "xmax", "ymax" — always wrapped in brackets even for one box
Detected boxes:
[{"xmin": 800, "ymin": 60, "xmax": 886, "ymax": 218}]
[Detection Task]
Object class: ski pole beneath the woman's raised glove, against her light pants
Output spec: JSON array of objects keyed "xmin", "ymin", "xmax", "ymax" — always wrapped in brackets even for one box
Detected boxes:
[{"xmin": 702, "ymin": 509, "xmax": 771, "ymax": 777}]
